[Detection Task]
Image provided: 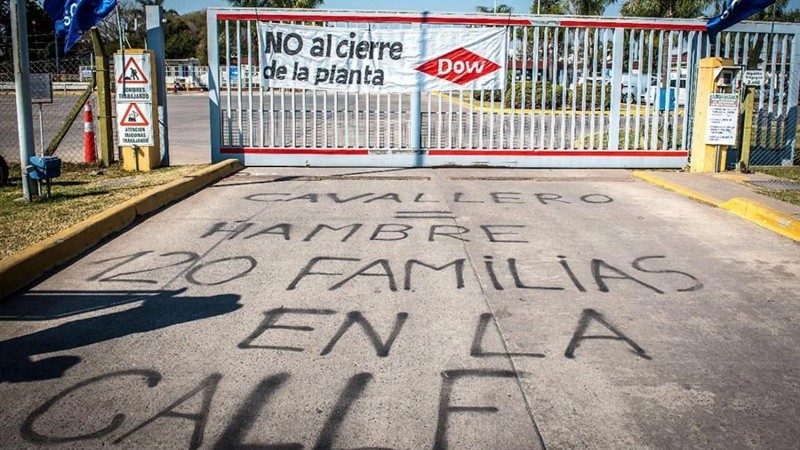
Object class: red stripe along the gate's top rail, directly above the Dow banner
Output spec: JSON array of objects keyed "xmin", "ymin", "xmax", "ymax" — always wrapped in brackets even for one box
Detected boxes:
[{"xmin": 217, "ymin": 12, "xmax": 531, "ymax": 26}]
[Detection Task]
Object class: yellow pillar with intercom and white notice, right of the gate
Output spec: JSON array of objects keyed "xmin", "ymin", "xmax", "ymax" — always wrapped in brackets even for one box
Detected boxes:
[{"xmin": 690, "ymin": 57, "xmax": 741, "ymax": 172}]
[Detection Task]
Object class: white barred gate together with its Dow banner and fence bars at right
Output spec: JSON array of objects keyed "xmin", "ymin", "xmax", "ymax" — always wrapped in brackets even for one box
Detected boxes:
[{"xmin": 208, "ymin": 8, "xmax": 800, "ymax": 168}]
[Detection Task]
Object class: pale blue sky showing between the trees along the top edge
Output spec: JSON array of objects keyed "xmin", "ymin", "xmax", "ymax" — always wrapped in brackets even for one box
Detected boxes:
[{"xmin": 164, "ymin": 0, "xmax": 800, "ymax": 16}]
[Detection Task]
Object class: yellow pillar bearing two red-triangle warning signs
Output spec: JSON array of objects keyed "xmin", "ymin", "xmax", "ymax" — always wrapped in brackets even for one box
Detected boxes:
[{"xmin": 114, "ymin": 50, "xmax": 161, "ymax": 171}]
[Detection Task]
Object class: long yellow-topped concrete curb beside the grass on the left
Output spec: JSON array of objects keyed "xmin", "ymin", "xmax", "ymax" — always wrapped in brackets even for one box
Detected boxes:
[{"xmin": 0, "ymin": 159, "xmax": 242, "ymax": 300}]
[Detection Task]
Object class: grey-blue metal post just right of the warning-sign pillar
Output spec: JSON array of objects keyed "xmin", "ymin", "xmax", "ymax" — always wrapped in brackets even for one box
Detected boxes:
[{"xmin": 144, "ymin": 6, "xmax": 169, "ymax": 167}]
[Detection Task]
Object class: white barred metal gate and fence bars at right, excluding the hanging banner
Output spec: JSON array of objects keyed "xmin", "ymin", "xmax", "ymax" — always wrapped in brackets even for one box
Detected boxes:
[{"xmin": 208, "ymin": 8, "xmax": 800, "ymax": 168}]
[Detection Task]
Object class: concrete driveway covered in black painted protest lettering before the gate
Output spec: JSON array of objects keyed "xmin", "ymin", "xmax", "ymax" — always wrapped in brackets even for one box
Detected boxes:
[{"xmin": 0, "ymin": 168, "xmax": 800, "ymax": 449}]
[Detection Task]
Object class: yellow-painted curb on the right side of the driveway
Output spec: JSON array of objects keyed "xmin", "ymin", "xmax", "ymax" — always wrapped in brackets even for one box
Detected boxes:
[{"xmin": 633, "ymin": 170, "xmax": 800, "ymax": 242}]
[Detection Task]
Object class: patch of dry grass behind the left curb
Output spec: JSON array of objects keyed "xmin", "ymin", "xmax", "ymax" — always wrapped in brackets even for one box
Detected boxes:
[{"xmin": 0, "ymin": 163, "xmax": 204, "ymax": 259}]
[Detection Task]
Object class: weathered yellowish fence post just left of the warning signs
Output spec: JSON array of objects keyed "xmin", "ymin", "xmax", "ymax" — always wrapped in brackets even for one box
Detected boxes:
[{"xmin": 92, "ymin": 28, "xmax": 114, "ymax": 167}]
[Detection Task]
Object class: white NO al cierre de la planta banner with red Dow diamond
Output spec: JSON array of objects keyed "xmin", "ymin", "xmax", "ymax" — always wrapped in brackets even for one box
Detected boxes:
[{"xmin": 258, "ymin": 22, "xmax": 508, "ymax": 93}]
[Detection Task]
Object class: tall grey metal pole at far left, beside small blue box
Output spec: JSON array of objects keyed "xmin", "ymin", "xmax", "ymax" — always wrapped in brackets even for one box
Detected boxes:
[{"xmin": 11, "ymin": 0, "xmax": 38, "ymax": 202}]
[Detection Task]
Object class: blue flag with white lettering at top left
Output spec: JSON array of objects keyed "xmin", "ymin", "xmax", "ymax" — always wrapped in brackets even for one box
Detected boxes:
[{"xmin": 44, "ymin": 0, "xmax": 117, "ymax": 53}]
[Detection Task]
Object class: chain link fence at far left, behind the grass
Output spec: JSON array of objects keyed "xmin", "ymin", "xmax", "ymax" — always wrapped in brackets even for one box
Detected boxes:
[{"xmin": 0, "ymin": 58, "xmax": 97, "ymax": 163}]
